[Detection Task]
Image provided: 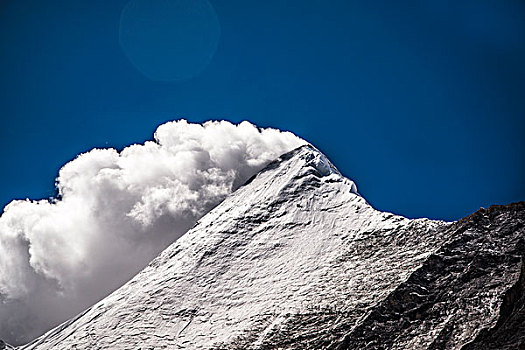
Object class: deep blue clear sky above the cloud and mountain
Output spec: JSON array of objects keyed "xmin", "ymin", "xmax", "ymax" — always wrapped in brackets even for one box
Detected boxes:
[{"xmin": 0, "ymin": 0, "xmax": 525, "ymax": 219}]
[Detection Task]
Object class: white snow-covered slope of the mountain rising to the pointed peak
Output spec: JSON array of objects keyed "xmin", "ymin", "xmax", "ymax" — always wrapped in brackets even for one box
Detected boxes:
[{"xmin": 18, "ymin": 146, "xmax": 511, "ymax": 350}]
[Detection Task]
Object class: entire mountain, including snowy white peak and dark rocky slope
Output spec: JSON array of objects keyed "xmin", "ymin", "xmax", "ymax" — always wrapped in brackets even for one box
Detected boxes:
[{"xmin": 17, "ymin": 146, "xmax": 525, "ymax": 350}]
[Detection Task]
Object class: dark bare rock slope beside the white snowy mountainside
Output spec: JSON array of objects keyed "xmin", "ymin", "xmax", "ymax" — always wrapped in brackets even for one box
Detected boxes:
[{"xmin": 331, "ymin": 202, "xmax": 525, "ymax": 349}]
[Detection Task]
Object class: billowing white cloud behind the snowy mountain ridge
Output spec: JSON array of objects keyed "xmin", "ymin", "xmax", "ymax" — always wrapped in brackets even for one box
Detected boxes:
[{"xmin": 0, "ymin": 120, "xmax": 305, "ymax": 344}]
